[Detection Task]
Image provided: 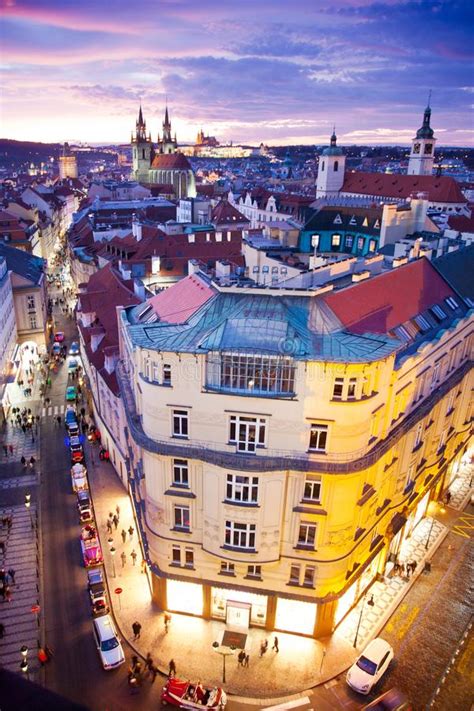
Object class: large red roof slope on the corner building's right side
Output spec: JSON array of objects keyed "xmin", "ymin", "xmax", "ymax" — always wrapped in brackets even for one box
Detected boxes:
[{"xmin": 323, "ymin": 258, "xmax": 455, "ymax": 333}]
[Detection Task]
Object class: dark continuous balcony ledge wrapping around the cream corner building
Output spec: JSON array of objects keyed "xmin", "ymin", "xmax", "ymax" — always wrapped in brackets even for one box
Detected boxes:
[{"xmin": 116, "ymin": 361, "xmax": 471, "ymax": 473}]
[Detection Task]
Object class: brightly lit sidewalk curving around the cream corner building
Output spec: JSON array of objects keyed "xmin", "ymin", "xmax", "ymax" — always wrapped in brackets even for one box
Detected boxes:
[{"xmin": 89, "ymin": 448, "xmax": 468, "ymax": 705}]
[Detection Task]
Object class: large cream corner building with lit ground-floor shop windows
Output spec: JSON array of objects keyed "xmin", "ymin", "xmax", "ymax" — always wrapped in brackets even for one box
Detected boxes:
[{"xmin": 117, "ymin": 259, "xmax": 473, "ymax": 637}]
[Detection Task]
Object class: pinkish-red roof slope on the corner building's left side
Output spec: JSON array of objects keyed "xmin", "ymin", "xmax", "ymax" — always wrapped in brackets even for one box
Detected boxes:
[{"xmin": 147, "ymin": 274, "xmax": 216, "ymax": 323}]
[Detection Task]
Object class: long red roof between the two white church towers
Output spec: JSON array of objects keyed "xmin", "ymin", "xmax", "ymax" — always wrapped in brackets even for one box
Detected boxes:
[{"xmin": 341, "ymin": 171, "xmax": 467, "ymax": 203}]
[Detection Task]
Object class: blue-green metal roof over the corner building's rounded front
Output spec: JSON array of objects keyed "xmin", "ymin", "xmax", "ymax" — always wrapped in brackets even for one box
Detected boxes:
[{"xmin": 127, "ymin": 291, "xmax": 401, "ymax": 362}]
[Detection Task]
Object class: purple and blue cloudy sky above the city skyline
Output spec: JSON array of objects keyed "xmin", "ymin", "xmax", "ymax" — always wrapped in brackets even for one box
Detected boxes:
[{"xmin": 0, "ymin": 0, "xmax": 474, "ymax": 145}]
